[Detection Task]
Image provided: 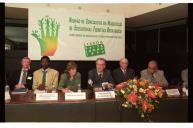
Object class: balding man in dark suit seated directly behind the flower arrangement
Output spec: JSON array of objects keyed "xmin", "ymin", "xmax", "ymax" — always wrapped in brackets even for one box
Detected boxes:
[{"xmin": 113, "ymin": 58, "xmax": 135, "ymax": 84}]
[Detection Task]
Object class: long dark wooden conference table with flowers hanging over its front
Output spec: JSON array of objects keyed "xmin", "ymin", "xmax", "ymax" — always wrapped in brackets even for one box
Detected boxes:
[{"xmin": 5, "ymin": 91, "xmax": 188, "ymax": 122}]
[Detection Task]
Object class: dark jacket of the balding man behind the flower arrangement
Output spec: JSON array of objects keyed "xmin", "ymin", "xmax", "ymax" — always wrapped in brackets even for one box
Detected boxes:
[{"xmin": 113, "ymin": 68, "xmax": 135, "ymax": 84}]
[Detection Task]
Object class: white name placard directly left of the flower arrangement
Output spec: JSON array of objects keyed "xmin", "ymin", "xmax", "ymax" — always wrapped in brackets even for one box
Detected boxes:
[{"xmin": 95, "ymin": 91, "xmax": 115, "ymax": 99}]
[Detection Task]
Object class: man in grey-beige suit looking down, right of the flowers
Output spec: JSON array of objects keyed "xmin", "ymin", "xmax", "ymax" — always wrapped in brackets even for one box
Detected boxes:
[{"xmin": 140, "ymin": 60, "xmax": 168, "ymax": 87}]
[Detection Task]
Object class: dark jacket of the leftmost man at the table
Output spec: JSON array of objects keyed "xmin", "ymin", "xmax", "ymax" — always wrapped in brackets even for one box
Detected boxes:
[{"xmin": 6, "ymin": 69, "xmax": 33, "ymax": 90}]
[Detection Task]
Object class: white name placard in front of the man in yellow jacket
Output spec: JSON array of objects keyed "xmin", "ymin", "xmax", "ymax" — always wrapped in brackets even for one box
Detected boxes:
[{"xmin": 36, "ymin": 93, "xmax": 58, "ymax": 101}]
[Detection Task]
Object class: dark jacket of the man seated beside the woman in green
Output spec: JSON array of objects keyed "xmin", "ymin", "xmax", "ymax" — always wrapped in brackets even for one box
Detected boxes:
[{"xmin": 88, "ymin": 69, "xmax": 114, "ymax": 87}]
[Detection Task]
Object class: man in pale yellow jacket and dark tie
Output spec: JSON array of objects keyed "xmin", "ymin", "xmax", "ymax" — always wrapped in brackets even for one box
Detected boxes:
[{"xmin": 32, "ymin": 56, "xmax": 59, "ymax": 91}]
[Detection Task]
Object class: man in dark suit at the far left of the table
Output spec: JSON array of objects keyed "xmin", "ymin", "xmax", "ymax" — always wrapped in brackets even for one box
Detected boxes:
[{"xmin": 7, "ymin": 57, "xmax": 33, "ymax": 90}]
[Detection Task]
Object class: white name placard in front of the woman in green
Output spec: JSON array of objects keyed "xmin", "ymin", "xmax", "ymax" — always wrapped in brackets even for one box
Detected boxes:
[{"xmin": 65, "ymin": 92, "xmax": 86, "ymax": 101}]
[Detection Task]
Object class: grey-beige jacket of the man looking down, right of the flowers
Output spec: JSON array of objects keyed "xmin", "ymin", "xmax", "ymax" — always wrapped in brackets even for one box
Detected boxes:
[{"xmin": 140, "ymin": 69, "xmax": 168, "ymax": 87}]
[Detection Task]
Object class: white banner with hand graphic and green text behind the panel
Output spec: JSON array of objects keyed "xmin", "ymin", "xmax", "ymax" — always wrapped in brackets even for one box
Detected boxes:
[{"xmin": 28, "ymin": 8, "xmax": 125, "ymax": 61}]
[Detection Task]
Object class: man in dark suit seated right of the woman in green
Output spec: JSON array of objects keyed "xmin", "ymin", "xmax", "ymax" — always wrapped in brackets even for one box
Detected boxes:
[{"xmin": 88, "ymin": 58, "xmax": 114, "ymax": 88}]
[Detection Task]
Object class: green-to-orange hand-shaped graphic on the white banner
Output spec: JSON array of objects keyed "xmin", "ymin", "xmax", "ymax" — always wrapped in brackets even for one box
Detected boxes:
[{"xmin": 31, "ymin": 16, "xmax": 60, "ymax": 56}]
